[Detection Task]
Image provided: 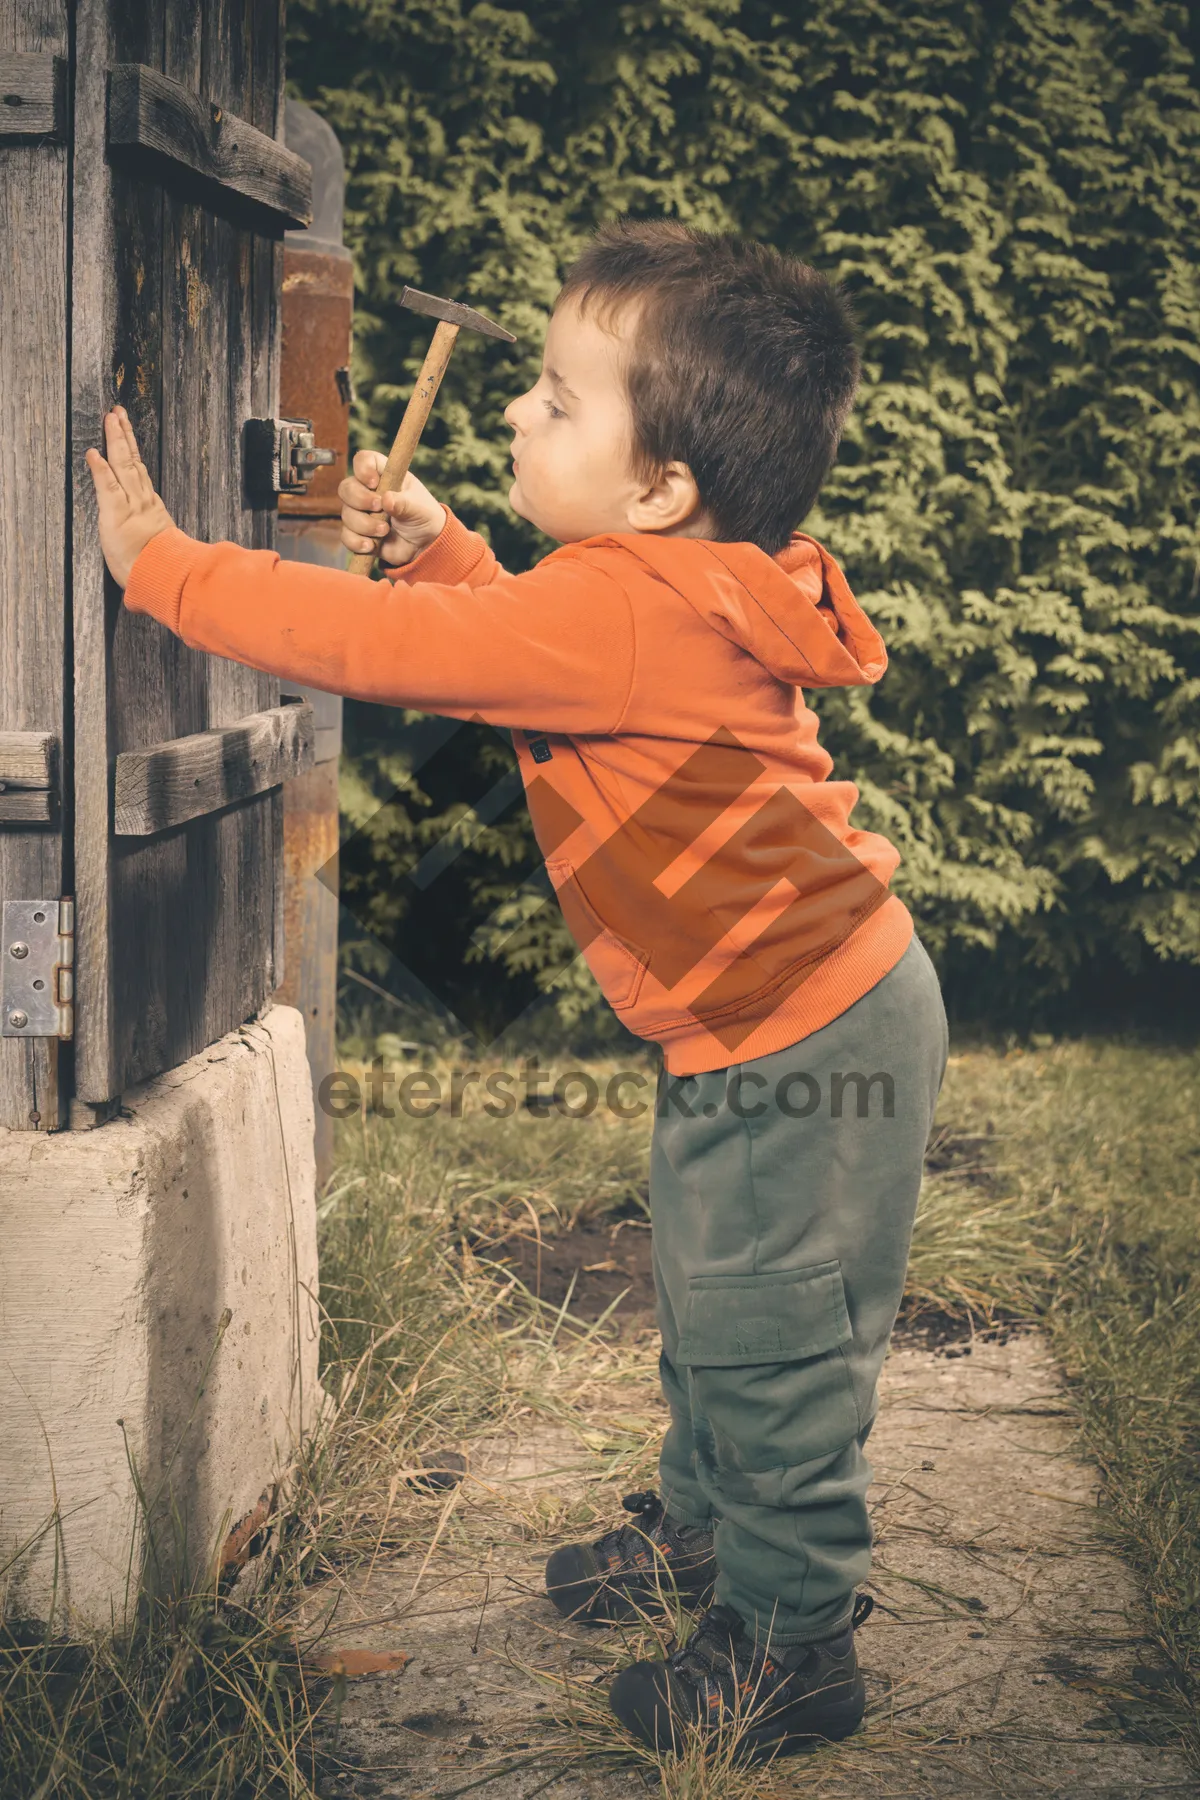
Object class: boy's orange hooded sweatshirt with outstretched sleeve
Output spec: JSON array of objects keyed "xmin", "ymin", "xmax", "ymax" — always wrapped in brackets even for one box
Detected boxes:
[{"xmin": 124, "ymin": 509, "xmax": 912, "ymax": 1075}]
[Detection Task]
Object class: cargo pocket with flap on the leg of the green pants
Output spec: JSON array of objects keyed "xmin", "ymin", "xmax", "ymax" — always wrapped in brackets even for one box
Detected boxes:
[{"xmin": 675, "ymin": 1262, "xmax": 862, "ymax": 1505}]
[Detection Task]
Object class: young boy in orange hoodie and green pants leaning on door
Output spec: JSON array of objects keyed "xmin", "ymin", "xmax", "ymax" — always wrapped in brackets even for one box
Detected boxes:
[{"xmin": 88, "ymin": 223, "xmax": 948, "ymax": 1753}]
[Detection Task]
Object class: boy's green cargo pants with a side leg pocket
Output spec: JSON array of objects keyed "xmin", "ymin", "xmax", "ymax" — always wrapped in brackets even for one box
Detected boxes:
[{"xmin": 649, "ymin": 936, "xmax": 948, "ymax": 1645}]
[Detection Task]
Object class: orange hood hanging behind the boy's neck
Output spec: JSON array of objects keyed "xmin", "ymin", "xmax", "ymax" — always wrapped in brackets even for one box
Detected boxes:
[{"xmin": 568, "ymin": 531, "xmax": 887, "ymax": 688}]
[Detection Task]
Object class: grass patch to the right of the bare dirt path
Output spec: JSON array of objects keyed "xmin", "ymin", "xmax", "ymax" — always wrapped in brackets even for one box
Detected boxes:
[{"xmin": 943, "ymin": 1040, "xmax": 1200, "ymax": 1768}]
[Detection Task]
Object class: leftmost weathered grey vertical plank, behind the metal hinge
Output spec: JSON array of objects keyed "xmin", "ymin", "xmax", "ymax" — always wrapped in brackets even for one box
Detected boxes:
[{"xmin": 0, "ymin": 0, "xmax": 70, "ymax": 1130}]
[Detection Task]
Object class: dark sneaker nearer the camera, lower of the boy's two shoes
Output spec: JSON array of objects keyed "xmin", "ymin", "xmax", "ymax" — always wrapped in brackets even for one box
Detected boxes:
[{"xmin": 608, "ymin": 1595, "xmax": 874, "ymax": 1762}]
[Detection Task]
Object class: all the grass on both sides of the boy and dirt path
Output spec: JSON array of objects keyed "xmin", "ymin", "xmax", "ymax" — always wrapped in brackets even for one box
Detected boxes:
[{"xmin": 0, "ymin": 1040, "xmax": 1200, "ymax": 1800}]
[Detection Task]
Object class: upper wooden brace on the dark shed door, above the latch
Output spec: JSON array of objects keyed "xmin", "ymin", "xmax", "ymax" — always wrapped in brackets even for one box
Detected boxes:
[{"xmin": 108, "ymin": 63, "xmax": 313, "ymax": 225}]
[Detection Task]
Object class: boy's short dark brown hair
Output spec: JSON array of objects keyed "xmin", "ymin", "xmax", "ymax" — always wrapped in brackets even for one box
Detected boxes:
[{"xmin": 556, "ymin": 220, "xmax": 858, "ymax": 556}]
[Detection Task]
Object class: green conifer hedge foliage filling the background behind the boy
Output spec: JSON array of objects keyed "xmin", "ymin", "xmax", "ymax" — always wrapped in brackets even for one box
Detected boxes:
[{"xmin": 290, "ymin": 0, "xmax": 1200, "ymax": 1006}]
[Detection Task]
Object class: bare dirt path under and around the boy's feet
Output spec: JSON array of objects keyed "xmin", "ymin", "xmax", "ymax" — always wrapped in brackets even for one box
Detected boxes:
[{"xmin": 302, "ymin": 1303, "xmax": 1198, "ymax": 1800}]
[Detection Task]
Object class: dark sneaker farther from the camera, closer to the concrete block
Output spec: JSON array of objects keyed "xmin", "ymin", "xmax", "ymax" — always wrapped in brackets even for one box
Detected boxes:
[{"xmin": 545, "ymin": 1494, "xmax": 716, "ymax": 1625}]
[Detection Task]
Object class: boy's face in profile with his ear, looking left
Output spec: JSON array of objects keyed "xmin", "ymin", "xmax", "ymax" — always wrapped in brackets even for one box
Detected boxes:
[{"xmin": 504, "ymin": 301, "xmax": 711, "ymax": 544}]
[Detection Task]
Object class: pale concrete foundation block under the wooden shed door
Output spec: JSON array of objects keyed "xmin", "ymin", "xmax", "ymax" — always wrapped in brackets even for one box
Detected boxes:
[{"xmin": 0, "ymin": 1004, "xmax": 320, "ymax": 1631}]
